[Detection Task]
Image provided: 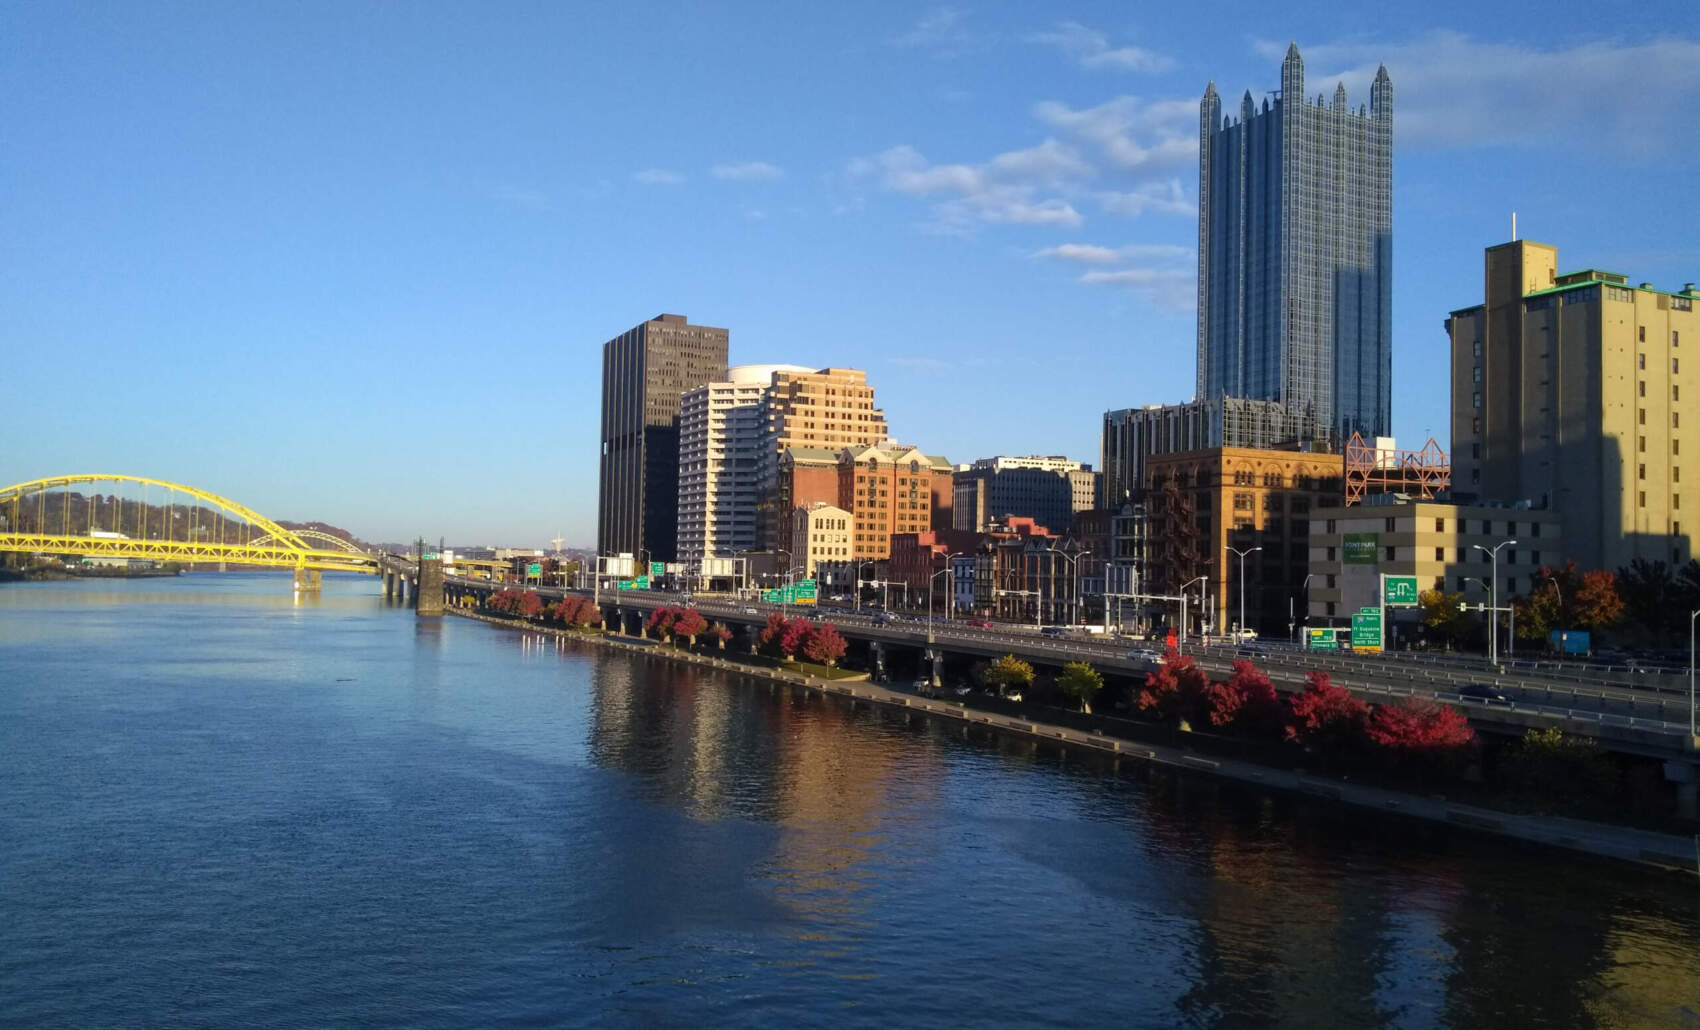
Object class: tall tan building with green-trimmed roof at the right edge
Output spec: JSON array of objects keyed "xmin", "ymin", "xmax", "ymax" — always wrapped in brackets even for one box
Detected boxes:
[{"xmin": 1447, "ymin": 240, "xmax": 1700, "ymax": 568}]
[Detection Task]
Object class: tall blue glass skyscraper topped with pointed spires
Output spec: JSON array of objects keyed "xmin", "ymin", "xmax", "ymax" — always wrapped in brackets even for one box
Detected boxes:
[{"xmin": 1199, "ymin": 46, "xmax": 1392, "ymax": 439}]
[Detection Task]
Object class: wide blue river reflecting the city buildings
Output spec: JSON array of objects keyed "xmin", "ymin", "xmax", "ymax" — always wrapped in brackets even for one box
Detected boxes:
[{"xmin": 0, "ymin": 573, "xmax": 1700, "ymax": 1028}]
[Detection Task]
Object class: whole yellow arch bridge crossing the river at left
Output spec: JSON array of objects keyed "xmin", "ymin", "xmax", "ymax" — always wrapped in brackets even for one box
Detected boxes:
[{"xmin": 0, "ymin": 473, "xmax": 381, "ymax": 583}]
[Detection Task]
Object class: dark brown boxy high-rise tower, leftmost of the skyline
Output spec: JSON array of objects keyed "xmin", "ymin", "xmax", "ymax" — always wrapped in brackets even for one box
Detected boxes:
[{"xmin": 597, "ymin": 314, "xmax": 729, "ymax": 561}]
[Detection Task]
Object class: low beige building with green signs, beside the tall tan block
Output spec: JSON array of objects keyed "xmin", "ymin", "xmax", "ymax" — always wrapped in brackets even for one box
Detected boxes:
[{"xmin": 1301, "ymin": 501, "xmax": 1566, "ymax": 639}]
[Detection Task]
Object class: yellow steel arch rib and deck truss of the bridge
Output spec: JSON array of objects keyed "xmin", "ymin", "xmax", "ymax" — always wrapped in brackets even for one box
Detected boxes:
[{"xmin": 0, "ymin": 473, "xmax": 377, "ymax": 573}]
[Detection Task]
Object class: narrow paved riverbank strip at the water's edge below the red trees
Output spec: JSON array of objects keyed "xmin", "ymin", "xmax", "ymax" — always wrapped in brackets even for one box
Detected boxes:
[{"xmin": 449, "ymin": 608, "xmax": 1700, "ymax": 875}]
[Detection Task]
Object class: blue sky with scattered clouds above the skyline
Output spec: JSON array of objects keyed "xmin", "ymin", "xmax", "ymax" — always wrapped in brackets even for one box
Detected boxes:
[{"xmin": 0, "ymin": 3, "xmax": 1700, "ymax": 546}]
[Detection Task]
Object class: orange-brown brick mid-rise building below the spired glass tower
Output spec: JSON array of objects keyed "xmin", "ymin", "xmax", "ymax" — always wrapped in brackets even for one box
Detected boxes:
[{"xmin": 1148, "ymin": 447, "xmax": 1345, "ymax": 636}]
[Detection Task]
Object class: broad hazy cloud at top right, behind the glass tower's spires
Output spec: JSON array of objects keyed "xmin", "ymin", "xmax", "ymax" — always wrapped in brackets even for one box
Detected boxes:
[{"xmin": 1258, "ymin": 31, "xmax": 1700, "ymax": 160}]
